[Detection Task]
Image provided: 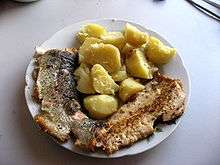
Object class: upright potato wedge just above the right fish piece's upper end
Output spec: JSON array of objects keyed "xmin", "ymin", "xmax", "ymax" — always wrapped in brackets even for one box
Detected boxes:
[{"xmin": 126, "ymin": 49, "xmax": 153, "ymax": 79}]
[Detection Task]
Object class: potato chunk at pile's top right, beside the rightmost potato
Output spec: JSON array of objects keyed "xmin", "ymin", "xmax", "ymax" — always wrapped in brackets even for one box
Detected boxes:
[{"xmin": 124, "ymin": 23, "xmax": 149, "ymax": 47}]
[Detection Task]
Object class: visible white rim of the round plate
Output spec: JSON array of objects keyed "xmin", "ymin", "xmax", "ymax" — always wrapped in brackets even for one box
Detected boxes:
[{"xmin": 24, "ymin": 18, "xmax": 191, "ymax": 159}]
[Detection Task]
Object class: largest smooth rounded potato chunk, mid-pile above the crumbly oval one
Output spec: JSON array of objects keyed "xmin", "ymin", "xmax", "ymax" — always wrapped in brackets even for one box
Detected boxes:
[{"xmin": 83, "ymin": 43, "xmax": 121, "ymax": 73}]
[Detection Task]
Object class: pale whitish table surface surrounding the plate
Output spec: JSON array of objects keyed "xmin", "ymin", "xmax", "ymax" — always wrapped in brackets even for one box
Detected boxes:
[{"xmin": 0, "ymin": 0, "xmax": 220, "ymax": 165}]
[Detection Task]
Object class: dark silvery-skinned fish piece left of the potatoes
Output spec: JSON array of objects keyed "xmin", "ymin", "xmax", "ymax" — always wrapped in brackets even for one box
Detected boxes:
[{"xmin": 33, "ymin": 49, "xmax": 101, "ymax": 146}]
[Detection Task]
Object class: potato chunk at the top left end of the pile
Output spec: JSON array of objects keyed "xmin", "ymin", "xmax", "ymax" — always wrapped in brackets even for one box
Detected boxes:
[{"xmin": 77, "ymin": 23, "xmax": 107, "ymax": 43}]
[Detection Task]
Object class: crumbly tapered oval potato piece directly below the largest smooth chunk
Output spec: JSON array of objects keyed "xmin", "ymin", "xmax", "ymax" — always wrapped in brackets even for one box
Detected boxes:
[{"xmin": 91, "ymin": 64, "xmax": 119, "ymax": 94}]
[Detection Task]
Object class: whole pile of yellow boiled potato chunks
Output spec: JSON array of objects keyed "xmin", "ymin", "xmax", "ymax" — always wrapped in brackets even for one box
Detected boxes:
[{"xmin": 74, "ymin": 23, "xmax": 176, "ymax": 119}]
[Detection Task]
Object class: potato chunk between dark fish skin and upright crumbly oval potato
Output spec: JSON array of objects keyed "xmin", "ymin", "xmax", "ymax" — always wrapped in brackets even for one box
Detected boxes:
[{"xmin": 74, "ymin": 64, "xmax": 95, "ymax": 94}]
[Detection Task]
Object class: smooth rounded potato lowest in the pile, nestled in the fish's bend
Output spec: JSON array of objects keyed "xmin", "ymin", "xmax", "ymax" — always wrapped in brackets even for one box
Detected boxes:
[{"xmin": 84, "ymin": 95, "xmax": 118, "ymax": 119}]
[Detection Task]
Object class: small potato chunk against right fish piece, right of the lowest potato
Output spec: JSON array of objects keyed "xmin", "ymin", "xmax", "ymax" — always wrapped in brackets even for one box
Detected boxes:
[{"xmin": 119, "ymin": 78, "xmax": 144, "ymax": 102}]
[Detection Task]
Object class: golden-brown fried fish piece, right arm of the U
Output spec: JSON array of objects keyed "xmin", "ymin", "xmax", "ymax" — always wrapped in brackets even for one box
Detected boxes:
[{"xmin": 94, "ymin": 75, "xmax": 185, "ymax": 154}]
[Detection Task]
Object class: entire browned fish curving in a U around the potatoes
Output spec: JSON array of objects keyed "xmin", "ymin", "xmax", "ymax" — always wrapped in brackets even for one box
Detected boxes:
[{"xmin": 33, "ymin": 49, "xmax": 185, "ymax": 154}]
